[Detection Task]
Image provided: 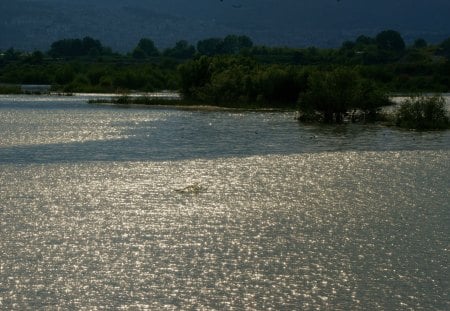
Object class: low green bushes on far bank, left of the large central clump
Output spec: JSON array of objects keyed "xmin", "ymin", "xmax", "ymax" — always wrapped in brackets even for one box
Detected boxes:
[{"xmin": 0, "ymin": 54, "xmax": 179, "ymax": 92}]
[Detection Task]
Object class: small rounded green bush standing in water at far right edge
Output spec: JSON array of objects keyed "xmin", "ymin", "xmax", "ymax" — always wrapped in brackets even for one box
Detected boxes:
[{"xmin": 396, "ymin": 96, "xmax": 450, "ymax": 130}]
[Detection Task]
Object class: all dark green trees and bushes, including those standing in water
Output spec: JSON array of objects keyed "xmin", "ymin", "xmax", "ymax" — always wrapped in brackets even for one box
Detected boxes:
[{"xmin": 0, "ymin": 30, "xmax": 450, "ymax": 129}]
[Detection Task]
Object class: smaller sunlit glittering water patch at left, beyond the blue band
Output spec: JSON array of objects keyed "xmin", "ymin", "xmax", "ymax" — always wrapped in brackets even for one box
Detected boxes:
[{"xmin": 0, "ymin": 101, "xmax": 169, "ymax": 147}]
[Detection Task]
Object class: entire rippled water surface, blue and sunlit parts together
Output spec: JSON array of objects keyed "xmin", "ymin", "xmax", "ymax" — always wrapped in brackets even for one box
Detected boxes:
[{"xmin": 0, "ymin": 96, "xmax": 450, "ymax": 310}]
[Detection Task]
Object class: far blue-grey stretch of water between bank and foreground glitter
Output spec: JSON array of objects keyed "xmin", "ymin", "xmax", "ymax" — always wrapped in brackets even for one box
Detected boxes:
[{"xmin": 0, "ymin": 97, "xmax": 450, "ymax": 164}]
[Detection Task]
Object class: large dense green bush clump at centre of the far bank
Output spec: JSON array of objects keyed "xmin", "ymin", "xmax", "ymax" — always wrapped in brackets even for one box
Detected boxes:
[{"xmin": 179, "ymin": 56, "xmax": 306, "ymax": 108}]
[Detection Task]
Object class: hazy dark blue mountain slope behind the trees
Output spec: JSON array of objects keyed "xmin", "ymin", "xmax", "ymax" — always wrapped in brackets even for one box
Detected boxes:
[{"xmin": 0, "ymin": 0, "xmax": 450, "ymax": 52}]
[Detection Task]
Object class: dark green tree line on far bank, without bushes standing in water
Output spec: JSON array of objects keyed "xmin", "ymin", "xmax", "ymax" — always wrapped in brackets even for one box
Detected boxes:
[{"xmin": 0, "ymin": 30, "xmax": 450, "ymax": 100}]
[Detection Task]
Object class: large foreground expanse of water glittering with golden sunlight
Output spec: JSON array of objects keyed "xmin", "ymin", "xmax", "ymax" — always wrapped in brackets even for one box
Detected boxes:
[{"xmin": 0, "ymin": 152, "xmax": 449, "ymax": 309}]
